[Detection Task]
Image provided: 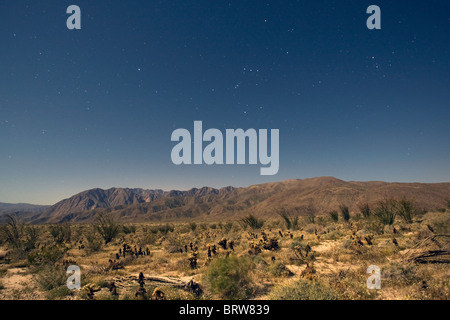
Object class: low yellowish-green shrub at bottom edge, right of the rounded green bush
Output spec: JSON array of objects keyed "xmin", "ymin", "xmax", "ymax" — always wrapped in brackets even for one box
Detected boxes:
[{"xmin": 269, "ymin": 279, "xmax": 338, "ymax": 300}]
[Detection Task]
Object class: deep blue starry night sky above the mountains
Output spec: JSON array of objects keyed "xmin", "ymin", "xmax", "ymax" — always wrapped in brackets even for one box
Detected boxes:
[{"xmin": 0, "ymin": 0, "xmax": 450, "ymax": 204}]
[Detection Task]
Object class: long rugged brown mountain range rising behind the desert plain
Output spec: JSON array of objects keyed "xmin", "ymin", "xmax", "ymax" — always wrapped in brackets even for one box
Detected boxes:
[{"xmin": 19, "ymin": 177, "xmax": 450, "ymax": 223}]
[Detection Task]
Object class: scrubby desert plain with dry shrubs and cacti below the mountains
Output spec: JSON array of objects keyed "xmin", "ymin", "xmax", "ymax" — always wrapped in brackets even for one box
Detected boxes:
[{"xmin": 0, "ymin": 198, "xmax": 450, "ymax": 300}]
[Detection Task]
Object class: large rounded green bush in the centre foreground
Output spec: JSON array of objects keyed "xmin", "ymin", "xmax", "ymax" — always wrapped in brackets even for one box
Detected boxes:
[{"xmin": 205, "ymin": 256, "xmax": 252, "ymax": 300}]
